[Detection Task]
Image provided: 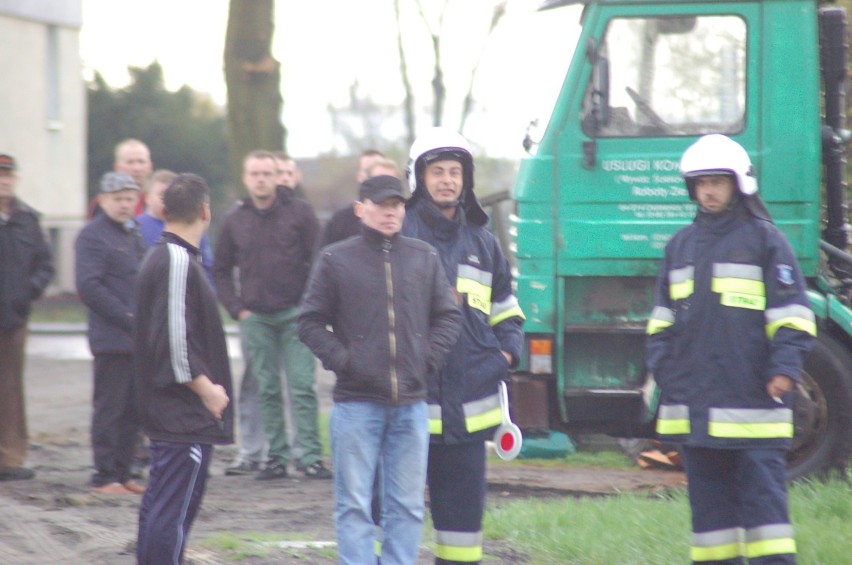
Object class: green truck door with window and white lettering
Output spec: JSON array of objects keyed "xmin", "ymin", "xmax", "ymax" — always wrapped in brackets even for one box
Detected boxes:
[{"xmin": 557, "ymin": 7, "xmax": 758, "ymax": 276}]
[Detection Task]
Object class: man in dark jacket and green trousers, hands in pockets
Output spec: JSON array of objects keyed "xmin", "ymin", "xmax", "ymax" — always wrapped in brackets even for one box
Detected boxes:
[{"xmin": 213, "ymin": 151, "xmax": 331, "ymax": 480}]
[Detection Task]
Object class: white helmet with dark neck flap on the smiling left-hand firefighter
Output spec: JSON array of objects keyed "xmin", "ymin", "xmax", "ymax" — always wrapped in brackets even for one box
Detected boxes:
[{"xmin": 405, "ymin": 127, "xmax": 488, "ymax": 225}]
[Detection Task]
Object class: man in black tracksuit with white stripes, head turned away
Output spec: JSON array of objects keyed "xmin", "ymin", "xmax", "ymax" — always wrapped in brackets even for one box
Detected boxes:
[{"xmin": 135, "ymin": 174, "xmax": 233, "ymax": 565}]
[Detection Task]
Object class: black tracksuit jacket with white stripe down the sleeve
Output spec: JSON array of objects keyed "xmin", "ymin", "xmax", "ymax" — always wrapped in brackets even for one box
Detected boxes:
[{"xmin": 135, "ymin": 232, "xmax": 234, "ymax": 444}]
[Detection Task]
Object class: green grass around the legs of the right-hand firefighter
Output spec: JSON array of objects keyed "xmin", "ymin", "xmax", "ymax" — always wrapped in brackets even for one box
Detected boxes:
[{"xmin": 484, "ymin": 464, "xmax": 852, "ymax": 565}]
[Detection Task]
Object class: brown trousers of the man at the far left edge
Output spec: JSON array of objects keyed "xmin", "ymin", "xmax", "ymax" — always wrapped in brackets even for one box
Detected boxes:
[{"xmin": 0, "ymin": 325, "xmax": 27, "ymax": 468}]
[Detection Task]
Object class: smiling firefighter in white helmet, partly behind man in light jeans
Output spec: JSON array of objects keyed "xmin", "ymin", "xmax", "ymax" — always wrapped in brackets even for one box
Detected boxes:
[{"xmin": 402, "ymin": 128, "xmax": 524, "ymax": 564}]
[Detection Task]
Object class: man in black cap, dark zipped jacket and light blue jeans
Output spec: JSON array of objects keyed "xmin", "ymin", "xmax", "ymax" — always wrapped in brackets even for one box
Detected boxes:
[{"xmin": 299, "ymin": 176, "xmax": 460, "ymax": 564}]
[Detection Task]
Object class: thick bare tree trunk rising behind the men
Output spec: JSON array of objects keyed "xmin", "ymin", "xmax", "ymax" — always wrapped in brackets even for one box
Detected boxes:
[{"xmin": 224, "ymin": 0, "xmax": 287, "ymax": 189}]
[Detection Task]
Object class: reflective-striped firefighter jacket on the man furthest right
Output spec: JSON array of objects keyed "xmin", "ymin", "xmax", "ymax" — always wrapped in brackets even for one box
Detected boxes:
[{"xmin": 647, "ymin": 204, "xmax": 816, "ymax": 449}]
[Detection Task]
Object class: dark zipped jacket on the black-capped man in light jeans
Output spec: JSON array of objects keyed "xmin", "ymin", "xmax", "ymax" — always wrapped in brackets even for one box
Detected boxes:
[{"xmin": 299, "ymin": 226, "xmax": 461, "ymax": 405}]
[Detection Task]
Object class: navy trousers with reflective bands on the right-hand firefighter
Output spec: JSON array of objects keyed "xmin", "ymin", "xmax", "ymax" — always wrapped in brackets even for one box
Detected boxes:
[{"xmin": 683, "ymin": 447, "xmax": 796, "ymax": 565}]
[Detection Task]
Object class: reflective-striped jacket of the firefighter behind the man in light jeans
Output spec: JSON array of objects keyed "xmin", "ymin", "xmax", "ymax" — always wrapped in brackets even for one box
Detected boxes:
[{"xmin": 402, "ymin": 199, "xmax": 524, "ymax": 444}]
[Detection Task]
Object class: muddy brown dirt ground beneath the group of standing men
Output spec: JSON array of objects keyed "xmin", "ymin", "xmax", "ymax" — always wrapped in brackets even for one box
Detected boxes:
[{"xmin": 0, "ymin": 335, "xmax": 684, "ymax": 565}]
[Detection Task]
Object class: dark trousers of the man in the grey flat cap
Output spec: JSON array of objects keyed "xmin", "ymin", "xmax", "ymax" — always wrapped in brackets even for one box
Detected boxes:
[{"xmin": 92, "ymin": 353, "xmax": 139, "ymax": 487}]
